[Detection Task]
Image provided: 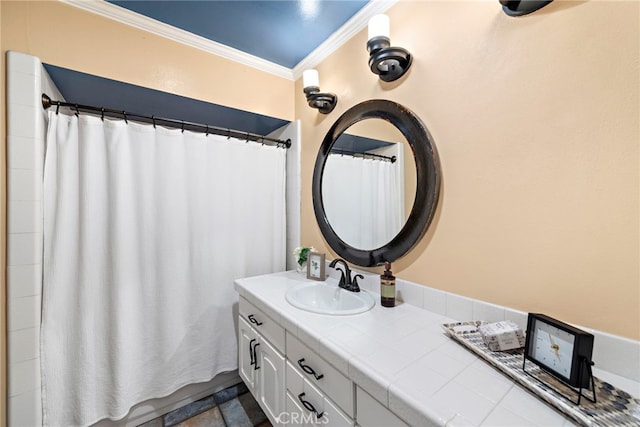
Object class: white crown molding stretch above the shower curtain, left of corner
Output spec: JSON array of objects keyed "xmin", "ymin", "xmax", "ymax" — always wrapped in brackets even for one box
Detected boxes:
[{"xmin": 60, "ymin": 0, "xmax": 293, "ymax": 80}]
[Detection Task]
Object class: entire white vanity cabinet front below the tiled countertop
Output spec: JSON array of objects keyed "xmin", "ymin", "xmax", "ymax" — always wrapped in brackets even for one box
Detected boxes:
[{"xmin": 238, "ymin": 297, "xmax": 406, "ymax": 427}]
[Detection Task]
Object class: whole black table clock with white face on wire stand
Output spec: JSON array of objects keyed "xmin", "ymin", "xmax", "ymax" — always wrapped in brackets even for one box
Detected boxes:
[{"xmin": 522, "ymin": 313, "xmax": 596, "ymax": 404}]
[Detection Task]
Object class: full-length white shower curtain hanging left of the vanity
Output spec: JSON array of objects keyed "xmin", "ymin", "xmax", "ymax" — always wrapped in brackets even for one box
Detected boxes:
[{"xmin": 41, "ymin": 113, "xmax": 286, "ymax": 426}]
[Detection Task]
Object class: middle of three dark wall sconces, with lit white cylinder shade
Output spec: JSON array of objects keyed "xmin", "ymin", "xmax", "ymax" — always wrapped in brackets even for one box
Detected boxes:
[{"xmin": 367, "ymin": 15, "xmax": 413, "ymax": 82}]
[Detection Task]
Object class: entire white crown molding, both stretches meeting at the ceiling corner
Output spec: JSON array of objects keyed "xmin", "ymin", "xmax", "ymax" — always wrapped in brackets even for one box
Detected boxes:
[{"xmin": 59, "ymin": 0, "xmax": 398, "ymax": 80}]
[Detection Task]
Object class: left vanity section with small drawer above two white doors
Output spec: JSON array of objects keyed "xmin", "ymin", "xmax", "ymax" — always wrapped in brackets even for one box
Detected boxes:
[{"xmin": 238, "ymin": 298, "xmax": 286, "ymax": 424}]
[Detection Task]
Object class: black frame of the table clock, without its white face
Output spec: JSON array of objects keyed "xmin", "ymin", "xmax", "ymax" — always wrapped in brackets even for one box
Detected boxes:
[{"xmin": 523, "ymin": 313, "xmax": 594, "ymax": 389}]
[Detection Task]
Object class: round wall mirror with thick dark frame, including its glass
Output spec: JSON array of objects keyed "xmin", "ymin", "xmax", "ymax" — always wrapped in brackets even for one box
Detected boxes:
[{"xmin": 312, "ymin": 100, "xmax": 440, "ymax": 267}]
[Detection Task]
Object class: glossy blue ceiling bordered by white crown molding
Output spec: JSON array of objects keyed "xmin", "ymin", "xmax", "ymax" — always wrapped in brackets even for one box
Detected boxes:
[{"xmin": 108, "ymin": 0, "xmax": 368, "ymax": 68}]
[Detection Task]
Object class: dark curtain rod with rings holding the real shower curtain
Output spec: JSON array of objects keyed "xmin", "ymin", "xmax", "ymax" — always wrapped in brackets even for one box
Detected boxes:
[{"xmin": 42, "ymin": 93, "xmax": 291, "ymax": 148}]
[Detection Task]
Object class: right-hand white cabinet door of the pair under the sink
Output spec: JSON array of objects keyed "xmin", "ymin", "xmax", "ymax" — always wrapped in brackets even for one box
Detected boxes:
[{"xmin": 256, "ymin": 339, "xmax": 286, "ymax": 421}]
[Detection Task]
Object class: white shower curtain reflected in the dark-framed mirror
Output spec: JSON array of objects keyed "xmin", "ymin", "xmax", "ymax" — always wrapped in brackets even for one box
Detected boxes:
[{"xmin": 322, "ymin": 154, "xmax": 405, "ymax": 249}]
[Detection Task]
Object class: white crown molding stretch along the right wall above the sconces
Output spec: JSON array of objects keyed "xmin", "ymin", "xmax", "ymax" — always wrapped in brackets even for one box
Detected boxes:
[{"xmin": 292, "ymin": 0, "xmax": 398, "ymax": 80}]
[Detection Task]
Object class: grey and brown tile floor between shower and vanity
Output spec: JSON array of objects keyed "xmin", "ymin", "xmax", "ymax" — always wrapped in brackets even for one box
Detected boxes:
[{"xmin": 139, "ymin": 382, "xmax": 271, "ymax": 427}]
